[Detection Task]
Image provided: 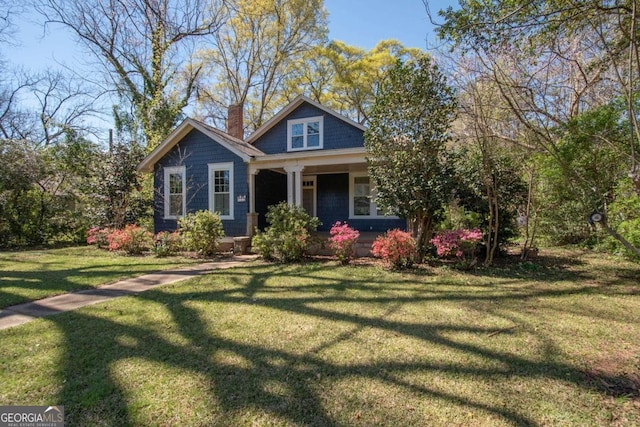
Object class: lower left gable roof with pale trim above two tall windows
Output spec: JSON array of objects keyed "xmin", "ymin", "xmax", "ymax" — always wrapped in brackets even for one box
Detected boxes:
[{"xmin": 138, "ymin": 118, "xmax": 264, "ymax": 172}]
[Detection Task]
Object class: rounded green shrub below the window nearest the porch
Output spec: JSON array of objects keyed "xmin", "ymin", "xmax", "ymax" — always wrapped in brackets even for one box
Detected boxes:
[{"xmin": 178, "ymin": 211, "xmax": 224, "ymax": 256}]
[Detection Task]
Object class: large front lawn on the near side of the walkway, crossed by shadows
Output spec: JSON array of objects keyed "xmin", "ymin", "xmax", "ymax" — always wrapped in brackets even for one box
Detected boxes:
[{"xmin": 0, "ymin": 251, "xmax": 640, "ymax": 426}]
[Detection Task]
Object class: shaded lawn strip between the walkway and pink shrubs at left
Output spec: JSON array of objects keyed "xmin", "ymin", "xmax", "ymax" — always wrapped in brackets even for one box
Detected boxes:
[{"xmin": 0, "ymin": 246, "xmax": 201, "ymax": 308}]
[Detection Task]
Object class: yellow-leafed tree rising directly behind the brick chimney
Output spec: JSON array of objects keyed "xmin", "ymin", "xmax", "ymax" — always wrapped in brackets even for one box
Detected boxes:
[{"xmin": 198, "ymin": 0, "xmax": 326, "ymax": 129}]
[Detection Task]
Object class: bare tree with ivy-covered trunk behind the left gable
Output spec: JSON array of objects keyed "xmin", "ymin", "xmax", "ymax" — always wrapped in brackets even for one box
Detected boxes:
[{"xmin": 35, "ymin": 0, "xmax": 226, "ymax": 150}]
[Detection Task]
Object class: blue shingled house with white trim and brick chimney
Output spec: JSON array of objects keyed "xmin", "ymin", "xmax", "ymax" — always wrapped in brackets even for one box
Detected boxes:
[{"xmin": 138, "ymin": 96, "xmax": 406, "ymax": 236}]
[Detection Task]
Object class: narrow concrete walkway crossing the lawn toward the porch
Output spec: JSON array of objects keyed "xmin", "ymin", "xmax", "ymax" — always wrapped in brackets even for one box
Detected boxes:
[{"xmin": 0, "ymin": 255, "xmax": 257, "ymax": 329}]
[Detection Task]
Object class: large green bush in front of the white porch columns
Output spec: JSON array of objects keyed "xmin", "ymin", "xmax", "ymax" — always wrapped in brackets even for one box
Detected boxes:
[{"xmin": 251, "ymin": 202, "xmax": 320, "ymax": 262}]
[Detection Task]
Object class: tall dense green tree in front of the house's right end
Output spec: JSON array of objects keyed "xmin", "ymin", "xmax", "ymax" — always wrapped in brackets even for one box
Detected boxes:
[{"xmin": 365, "ymin": 54, "xmax": 456, "ymax": 255}]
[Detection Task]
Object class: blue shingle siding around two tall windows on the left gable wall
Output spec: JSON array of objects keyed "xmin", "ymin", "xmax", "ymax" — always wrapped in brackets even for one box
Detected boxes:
[{"xmin": 154, "ymin": 129, "xmax": 249, "ymax": 236}]
